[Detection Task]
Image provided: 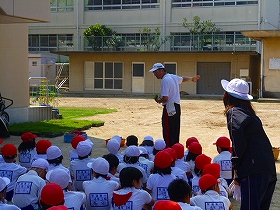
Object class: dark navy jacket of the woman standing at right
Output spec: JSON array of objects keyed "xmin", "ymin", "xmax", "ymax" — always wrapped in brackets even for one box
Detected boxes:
[{"xmin": 226, "ymin": 107, "xmax": 276, "ymax": 179}]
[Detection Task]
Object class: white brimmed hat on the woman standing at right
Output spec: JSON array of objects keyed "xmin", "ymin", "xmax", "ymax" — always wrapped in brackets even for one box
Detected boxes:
[{"xmin": 221, "ymin": 78, "xmax": 253, "ymax": 100}]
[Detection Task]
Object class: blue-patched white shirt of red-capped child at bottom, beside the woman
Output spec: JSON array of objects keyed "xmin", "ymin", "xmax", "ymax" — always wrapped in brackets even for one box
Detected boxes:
[{"xmin": 190, "ymin": 190, "xmax": 231, "ymax": 210}]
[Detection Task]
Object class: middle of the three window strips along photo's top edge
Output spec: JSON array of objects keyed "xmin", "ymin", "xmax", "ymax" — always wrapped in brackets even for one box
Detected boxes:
[{"xmin": 84, "ymin": 0, "xmax": 159, "ymax": 11}]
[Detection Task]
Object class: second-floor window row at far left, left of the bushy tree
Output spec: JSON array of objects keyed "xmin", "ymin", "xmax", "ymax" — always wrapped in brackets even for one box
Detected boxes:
[{"xmin": 28, "ymin": 34, "xmax": 73, "ymax": 52}]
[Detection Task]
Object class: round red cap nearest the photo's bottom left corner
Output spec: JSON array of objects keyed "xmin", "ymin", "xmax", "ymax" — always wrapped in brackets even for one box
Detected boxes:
[{"xmin": 41, "ymin": 182, "xmax": 64, "ymax": 206}]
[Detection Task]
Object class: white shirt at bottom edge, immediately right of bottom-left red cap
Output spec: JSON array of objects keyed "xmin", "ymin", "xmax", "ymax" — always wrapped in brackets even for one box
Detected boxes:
[{"xmin": 64, "ymin": 191, "xmax": 86, "ymax": 210}]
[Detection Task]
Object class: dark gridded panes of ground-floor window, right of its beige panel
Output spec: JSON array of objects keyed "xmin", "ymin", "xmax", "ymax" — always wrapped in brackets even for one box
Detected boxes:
[{"xmin": 92, "ymin": 62, "xmax": 123, "ymax": 90}]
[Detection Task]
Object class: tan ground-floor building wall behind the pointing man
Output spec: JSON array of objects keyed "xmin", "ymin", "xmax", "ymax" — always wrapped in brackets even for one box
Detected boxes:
[{"xmin": 66, "ymin": 52, "xmax": 259, "ymax": 94}]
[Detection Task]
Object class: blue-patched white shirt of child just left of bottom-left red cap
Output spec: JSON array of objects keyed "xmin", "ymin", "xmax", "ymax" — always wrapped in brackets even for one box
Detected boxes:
[{"xmin": 12, "ymin": 170, "xmax": 46, "ymax": 209}]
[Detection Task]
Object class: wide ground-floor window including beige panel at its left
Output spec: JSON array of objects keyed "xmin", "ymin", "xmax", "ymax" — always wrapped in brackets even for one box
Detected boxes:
[{"xmin": 84, "ymin": 62, "xmax": 123, "ymax": 90}]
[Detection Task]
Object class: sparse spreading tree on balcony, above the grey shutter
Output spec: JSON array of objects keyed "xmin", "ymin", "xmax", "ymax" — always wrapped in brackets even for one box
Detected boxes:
[{"xmin": 181, "ymin": 16, "xmax": 221, "ymax": 50}]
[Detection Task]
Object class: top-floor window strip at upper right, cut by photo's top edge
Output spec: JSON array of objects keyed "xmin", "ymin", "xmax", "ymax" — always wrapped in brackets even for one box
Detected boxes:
[{"xmin": 172, "ymin": 0, "xmax": 258, "ymax": 8}]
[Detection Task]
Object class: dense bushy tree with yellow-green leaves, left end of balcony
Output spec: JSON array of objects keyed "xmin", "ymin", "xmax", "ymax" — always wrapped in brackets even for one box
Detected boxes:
[{"xmin": 84, "ymin": 24, "xmax": 117, "ymax": 51}]
